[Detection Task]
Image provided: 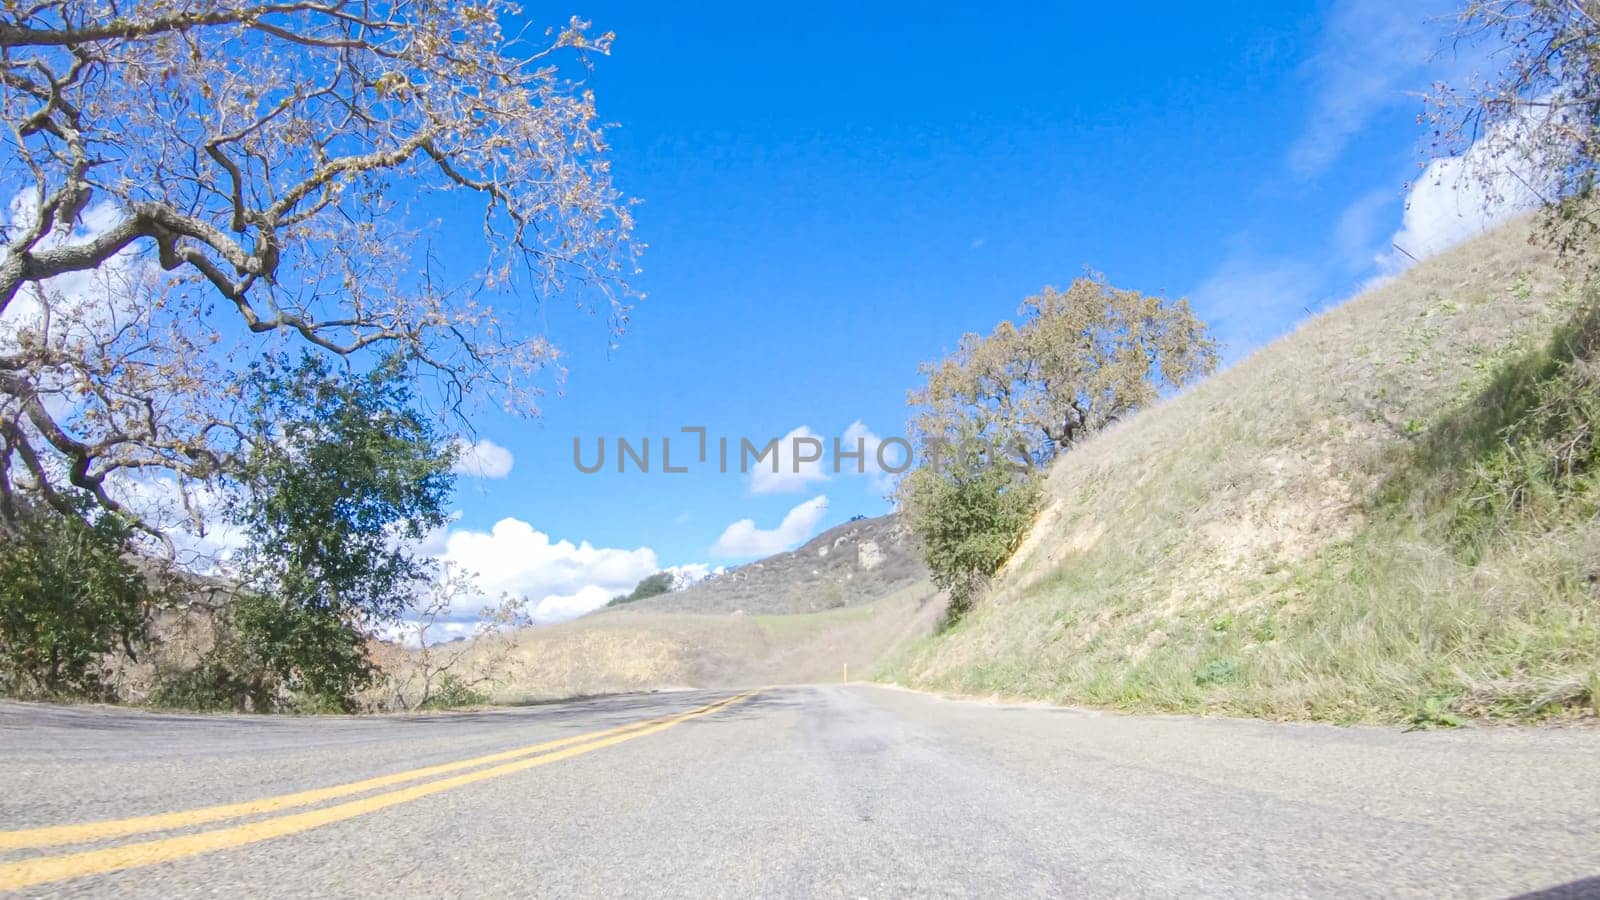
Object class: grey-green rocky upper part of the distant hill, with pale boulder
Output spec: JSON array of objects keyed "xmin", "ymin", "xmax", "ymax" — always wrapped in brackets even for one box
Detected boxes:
[{"xmin": 594, "ymin": 514, "xmax": 928, "ymax": 615}]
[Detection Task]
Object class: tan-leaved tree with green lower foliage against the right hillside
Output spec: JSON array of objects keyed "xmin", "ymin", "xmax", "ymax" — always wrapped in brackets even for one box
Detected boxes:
[{"xmin": 899, "ymin": 275, "xmax": 1216, "ymax": 625}]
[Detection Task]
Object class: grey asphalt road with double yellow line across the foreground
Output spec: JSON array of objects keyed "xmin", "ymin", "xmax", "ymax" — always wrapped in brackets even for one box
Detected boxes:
[{"xmin": 0, "ymin": 685, "xmax": 1600, "ymax": 898}]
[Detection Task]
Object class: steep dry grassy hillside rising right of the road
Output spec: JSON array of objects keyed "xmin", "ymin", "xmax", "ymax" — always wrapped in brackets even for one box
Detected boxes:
[{"xmin": 878, "ymin": 224, "xmax": 1600, "ymax": 724}]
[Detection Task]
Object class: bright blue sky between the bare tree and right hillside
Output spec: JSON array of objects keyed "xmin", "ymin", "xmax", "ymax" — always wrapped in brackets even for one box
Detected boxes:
[{"xmin": 419, "ymin": 0, "xmax": 1504, "ymax": 610}]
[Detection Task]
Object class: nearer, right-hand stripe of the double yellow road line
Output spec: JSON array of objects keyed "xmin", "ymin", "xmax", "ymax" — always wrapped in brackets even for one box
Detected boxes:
[{"xmin": 0, "ymin": 690, "xmax": 755, "ymax": 890}]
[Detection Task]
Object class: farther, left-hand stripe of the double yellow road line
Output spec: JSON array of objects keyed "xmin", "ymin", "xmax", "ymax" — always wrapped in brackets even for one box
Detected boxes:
[{"xmin": 0, "ymin": 688, "xmax": 742, "ymax": 850}]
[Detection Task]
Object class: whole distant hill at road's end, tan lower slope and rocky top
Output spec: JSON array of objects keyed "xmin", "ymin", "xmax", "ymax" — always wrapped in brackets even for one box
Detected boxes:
[{"xmin": 419, "ymin": 516, "xmax": 944, "ymax": 703}]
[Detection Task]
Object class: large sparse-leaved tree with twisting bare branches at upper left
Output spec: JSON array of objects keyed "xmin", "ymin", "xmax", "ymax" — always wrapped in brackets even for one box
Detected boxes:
[{"xmin": 0, "ymin": 0, "xmax": 635, "ymax": 533}]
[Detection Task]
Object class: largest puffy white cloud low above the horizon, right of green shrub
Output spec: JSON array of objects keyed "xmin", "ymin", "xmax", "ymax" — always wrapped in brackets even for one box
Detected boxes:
[{"xmin": 438, "ymin": 519, "xmax": 659, "ymax": 623}]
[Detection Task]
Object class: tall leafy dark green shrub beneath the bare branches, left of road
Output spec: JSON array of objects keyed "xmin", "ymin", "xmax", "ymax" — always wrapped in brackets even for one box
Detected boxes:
[{"xmin": 225, "ymin": 356, "xmax": 454, "ymax": 711}]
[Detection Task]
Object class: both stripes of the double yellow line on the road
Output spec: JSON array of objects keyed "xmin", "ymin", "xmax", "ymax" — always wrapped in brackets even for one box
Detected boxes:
[{"xmin": 0, "ymin": 690, "xmax": 755, "ymax": 890}]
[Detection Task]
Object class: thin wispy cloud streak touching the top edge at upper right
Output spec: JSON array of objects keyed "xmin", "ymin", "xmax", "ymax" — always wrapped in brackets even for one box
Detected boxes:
[{"xmin": 1288, "ymin": 0, "xmax": 1470, "ymax": 178}]
